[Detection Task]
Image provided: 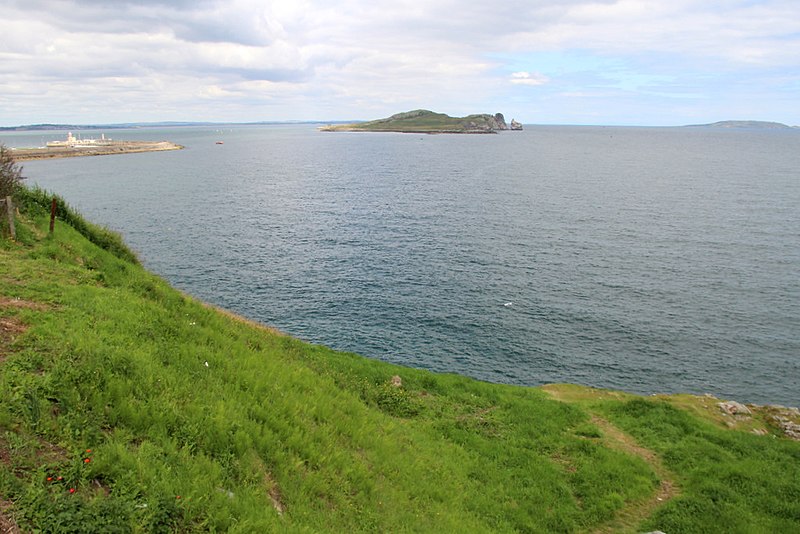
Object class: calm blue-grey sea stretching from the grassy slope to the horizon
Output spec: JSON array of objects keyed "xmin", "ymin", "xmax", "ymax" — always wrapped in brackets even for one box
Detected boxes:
[{"xmin": 7, "ymin": 125, "xmax": 800, "ymax": 405}]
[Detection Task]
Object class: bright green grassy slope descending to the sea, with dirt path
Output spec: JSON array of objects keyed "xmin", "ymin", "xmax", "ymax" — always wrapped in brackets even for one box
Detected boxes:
[{"xmin": 0, "ymin": 191, "xmax": 800, "ymax": 533}]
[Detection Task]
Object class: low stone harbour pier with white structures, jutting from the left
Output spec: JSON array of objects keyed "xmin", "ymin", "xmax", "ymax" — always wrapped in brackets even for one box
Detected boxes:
[{"xmin": 11, "ymin": 132, "xmax": 183, "ymax": 161}]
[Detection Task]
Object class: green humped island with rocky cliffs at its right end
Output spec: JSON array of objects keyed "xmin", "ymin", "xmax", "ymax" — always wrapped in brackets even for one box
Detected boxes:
[{"xmin": 319, "ymin": 109, "xmax": 522, "ymax": 134}]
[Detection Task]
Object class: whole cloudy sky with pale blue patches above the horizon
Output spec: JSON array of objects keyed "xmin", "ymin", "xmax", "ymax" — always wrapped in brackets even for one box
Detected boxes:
[{"xmin": 0, "ymin": 0, "xmax": 800, "ymax": 126}]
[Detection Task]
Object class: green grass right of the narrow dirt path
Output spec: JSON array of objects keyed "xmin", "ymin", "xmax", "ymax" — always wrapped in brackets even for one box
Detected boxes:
[{"xmin": 602, "ymin": 399, "xmax": 800, "ymax": 533}]
